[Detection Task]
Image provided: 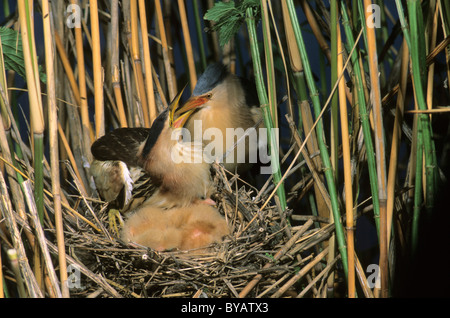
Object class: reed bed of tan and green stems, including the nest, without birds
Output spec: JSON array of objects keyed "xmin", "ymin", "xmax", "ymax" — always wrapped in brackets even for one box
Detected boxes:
[{"xmin": 0, "ymin": 0, "xmax": 450, "ymax": 298}]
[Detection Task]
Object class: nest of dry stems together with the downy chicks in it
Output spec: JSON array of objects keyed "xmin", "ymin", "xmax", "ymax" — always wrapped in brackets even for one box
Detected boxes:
[{"xmin": 66, "ymin": 166, "xmax": 333, "ymax": 297}]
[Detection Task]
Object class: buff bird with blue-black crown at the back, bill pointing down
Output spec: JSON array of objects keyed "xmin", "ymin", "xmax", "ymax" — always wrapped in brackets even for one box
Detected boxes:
[{"xmin": 176, "ymin": 63, "xmax": 266, "ymax": 172}]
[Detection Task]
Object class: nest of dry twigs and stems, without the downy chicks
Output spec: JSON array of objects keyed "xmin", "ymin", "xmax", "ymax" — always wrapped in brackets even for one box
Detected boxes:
[{"xmin": 59, "ymin": 164, "xmax": 336, "ymax": 298}]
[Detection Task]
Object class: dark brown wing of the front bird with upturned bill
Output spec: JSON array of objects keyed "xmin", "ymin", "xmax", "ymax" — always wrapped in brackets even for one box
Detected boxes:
[{"xmin": 91, "ymin": 128, "xmax": 150, "ymax": 167}]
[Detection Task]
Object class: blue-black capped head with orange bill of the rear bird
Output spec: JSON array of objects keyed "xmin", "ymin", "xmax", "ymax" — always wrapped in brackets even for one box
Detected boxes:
[{"xmin": 177, "ymin": 63, "xmax": 229, "ymax": 115}]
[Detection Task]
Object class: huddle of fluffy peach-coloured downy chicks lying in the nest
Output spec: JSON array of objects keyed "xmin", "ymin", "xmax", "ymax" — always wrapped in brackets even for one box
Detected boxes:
[{"xmin": 121, "ymin": 203, "xmax": 229, "ymax": 251}]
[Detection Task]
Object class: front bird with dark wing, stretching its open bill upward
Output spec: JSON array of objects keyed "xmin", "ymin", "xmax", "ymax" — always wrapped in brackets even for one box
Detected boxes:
[{"xmin": 90, "ymin": 87, "xmax": 212, "ymax": 232}]
